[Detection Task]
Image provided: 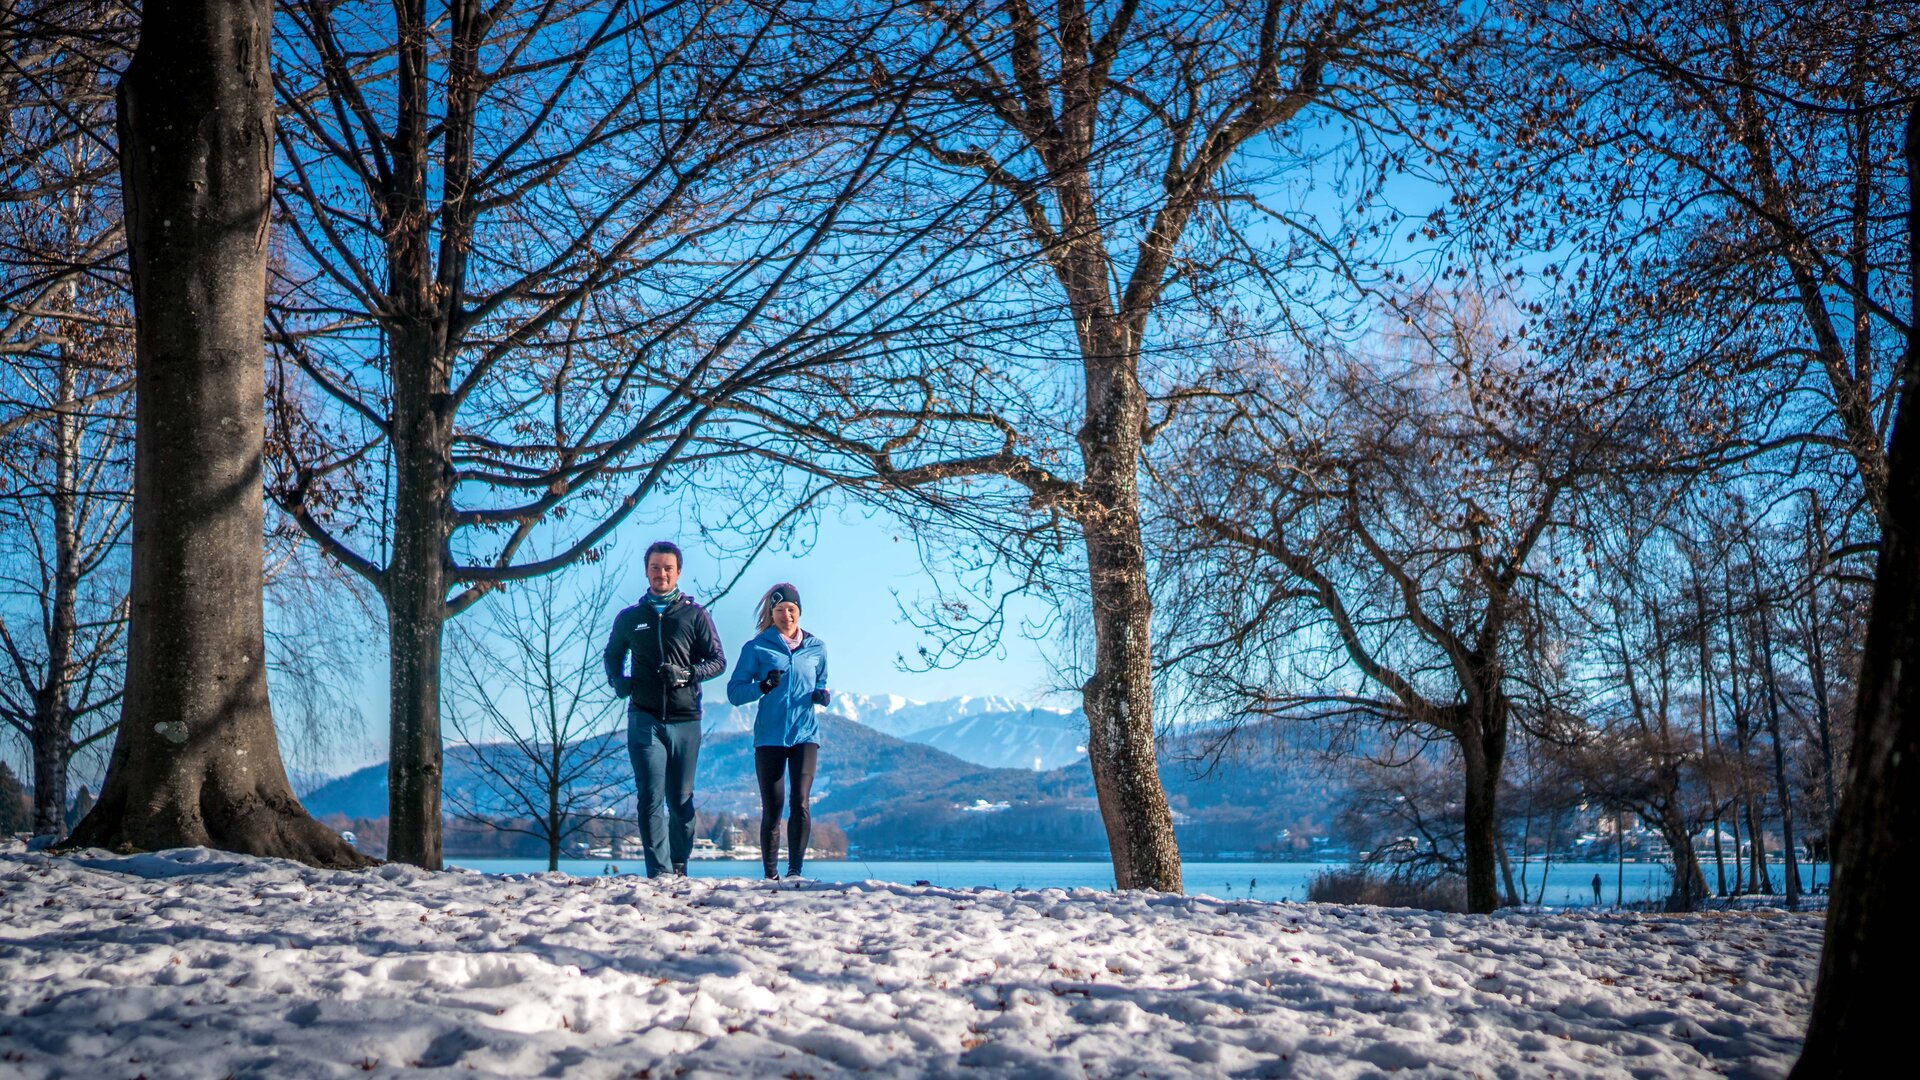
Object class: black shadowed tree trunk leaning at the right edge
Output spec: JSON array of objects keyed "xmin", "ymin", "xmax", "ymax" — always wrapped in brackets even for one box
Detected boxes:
[{"xmin": 1793, "ymin": 108, "xmax": 1920, "ymax": 1078}]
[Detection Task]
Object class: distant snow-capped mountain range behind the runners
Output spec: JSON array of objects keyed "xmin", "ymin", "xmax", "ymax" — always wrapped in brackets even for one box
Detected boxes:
[{"xmin": 703, "ymin": 690, "xmax": 1087, "ymax": 771}]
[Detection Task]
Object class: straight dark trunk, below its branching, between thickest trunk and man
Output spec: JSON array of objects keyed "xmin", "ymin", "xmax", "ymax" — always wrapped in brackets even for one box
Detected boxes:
[{"xmin": 380, "ymin": 327, "xmax": 453, "ymax": 871}]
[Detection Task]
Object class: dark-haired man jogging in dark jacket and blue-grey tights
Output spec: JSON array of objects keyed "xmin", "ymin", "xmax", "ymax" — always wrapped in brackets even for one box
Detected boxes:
[{"xmin": 601, "ymin": 540, "xmax": 726, "ymax": 878}]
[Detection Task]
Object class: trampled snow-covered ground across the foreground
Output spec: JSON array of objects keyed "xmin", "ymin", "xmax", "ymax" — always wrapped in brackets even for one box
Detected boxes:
[{"xmin": 0, "ymin": 847, "xmax": 1820, "ymax": 1080}]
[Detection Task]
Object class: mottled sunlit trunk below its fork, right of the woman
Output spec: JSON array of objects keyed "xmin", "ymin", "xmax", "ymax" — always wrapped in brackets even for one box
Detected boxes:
[{"xmin": 1079, "ymin": 320, "xmax": 1181, "ymax": 892}]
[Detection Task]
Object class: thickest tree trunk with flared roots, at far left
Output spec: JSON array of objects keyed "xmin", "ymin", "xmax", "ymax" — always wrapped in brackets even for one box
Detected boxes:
[{"xmin": 71, "ymin": 0, "xmax": 367, "ymax": 867}]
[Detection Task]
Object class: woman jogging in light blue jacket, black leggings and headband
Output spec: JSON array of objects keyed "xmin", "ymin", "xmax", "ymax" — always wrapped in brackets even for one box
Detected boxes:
[{"xmin": 726, "ymin": 582, "xmax": 831, "ymax": 878}]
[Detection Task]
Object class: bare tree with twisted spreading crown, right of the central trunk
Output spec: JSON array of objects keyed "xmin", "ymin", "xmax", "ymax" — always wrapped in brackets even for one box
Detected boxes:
[{"xmin": 1158, "ymin": 294, "xmax": 1670, "ymax": 911}]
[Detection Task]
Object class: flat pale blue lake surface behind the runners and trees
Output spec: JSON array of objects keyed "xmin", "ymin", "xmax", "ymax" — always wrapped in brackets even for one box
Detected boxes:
[{"xmin": 447, "ymin": 859, "xmax": 1826, "ymax": 907}]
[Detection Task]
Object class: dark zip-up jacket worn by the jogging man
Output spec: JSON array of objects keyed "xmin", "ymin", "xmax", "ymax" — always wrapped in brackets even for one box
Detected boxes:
[{"xmin": 601, "ymin": 594, "xmax": 726, "ymax": 723}]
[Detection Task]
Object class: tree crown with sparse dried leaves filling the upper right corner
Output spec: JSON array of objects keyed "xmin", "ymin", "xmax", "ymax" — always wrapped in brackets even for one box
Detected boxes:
[{"xmin": 1501, "ymin": 0, "xmax": 1914, "ymax": 530}]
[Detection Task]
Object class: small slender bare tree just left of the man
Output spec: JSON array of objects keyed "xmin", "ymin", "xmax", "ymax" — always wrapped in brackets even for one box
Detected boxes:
[{"xmin": 447, "ymin": 563, "xmax": 634, "ymax": 871}]
